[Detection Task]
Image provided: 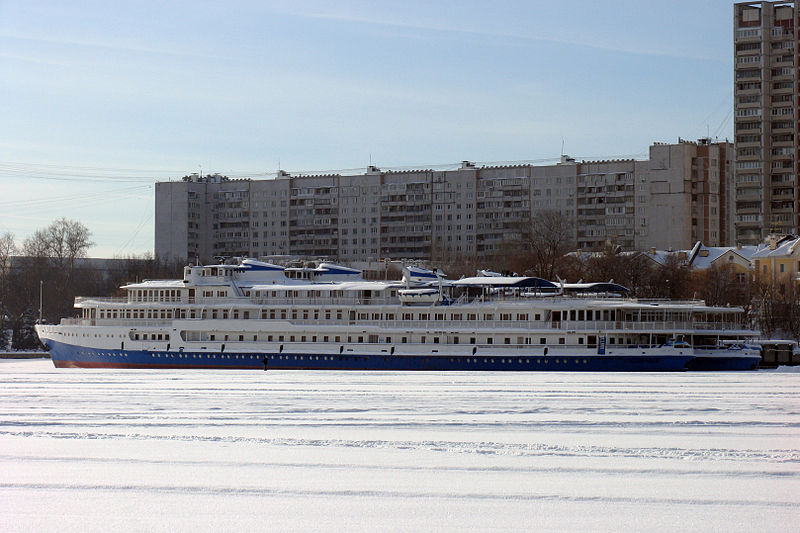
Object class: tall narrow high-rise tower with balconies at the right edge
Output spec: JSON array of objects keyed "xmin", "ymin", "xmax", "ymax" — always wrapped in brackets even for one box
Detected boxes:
[{"xmin": 733, "ymin": 1, "xmax": 800, "ymax": 244}]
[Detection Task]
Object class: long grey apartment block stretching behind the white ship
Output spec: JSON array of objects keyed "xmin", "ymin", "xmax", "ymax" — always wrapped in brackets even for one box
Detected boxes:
[{"xmin": 155, "ymin": 139, "xmax": 733, "ymax": 262}]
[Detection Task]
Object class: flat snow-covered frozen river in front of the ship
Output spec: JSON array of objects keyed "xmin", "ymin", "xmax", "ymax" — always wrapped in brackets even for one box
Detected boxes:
[{"xmin": 0, "ymin": 360, "xmax": 800, "ymax": 531}]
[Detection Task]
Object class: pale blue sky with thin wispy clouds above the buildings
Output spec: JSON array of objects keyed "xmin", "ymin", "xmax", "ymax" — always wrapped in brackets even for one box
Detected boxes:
[{"xmin": 0, "ymin": 0, "xmax": 733, "ymax": 256}]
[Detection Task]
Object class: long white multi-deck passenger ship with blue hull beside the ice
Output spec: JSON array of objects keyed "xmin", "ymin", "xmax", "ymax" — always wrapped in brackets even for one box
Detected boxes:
[{"xmin": 37, "ymin": 259, "xmax": 760, "ymax": 371}]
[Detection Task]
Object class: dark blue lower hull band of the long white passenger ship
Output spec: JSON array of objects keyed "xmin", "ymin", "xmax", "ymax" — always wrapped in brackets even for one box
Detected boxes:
[{"xmin": 40, "ymin": 339, "xmax": 693, "ymax": 372}]
